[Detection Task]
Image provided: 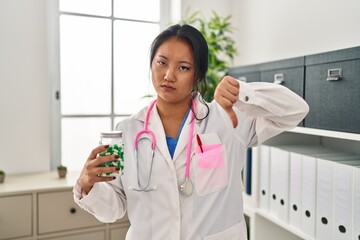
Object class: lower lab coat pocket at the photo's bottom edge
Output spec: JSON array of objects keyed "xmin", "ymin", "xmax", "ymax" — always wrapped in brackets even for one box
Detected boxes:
[{"xmin": 204, "ymin": 221, "xmax": 247, "ymax": 240}]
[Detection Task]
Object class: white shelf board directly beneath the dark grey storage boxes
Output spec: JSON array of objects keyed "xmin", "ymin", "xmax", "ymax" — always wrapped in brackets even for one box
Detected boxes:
[{"xmin": 288, "ymin": 127, "xmax": 360, "ymax": 141}]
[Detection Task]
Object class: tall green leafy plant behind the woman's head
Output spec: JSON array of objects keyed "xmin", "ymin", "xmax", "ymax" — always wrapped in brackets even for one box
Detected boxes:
[{"xmin": 182, "ymin": 9, "xmax": 237, "ymax": 102}]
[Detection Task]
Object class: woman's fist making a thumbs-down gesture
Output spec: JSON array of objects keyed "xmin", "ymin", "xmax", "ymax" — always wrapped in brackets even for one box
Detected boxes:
[{"xmin": 214, "ymin": 76, "xmax": 240, "ymax": 128}]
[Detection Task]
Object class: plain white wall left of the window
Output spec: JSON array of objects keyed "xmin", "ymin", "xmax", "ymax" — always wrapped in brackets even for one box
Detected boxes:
[{"xmin": 0, "ymin": 0, "xmax": 50, "ymax": 174}]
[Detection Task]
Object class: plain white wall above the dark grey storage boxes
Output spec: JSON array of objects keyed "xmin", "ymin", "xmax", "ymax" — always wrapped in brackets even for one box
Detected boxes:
[{"xmin": 231, "ymin": 0, "xmax": 360, "ymax": 65}]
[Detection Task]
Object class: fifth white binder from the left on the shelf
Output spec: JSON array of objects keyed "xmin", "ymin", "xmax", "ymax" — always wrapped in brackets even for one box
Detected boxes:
[{"xmin": 301, "ymin": 150, "xmax": 346, "ymax": 239}]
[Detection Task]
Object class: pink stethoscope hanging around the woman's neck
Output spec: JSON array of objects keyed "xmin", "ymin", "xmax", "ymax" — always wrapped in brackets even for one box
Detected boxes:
[{"xmin": 129, "ymin": 100, "xmax": 196, "ymax": 196}]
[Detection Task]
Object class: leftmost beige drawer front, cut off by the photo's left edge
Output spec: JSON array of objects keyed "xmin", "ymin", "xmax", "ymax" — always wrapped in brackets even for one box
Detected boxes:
[{"xmin": 0, "ymin": 194, "xmax": 33, "ymax": 239}]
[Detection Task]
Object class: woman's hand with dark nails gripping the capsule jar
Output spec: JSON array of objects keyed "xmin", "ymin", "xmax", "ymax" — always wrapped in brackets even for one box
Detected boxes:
[{"xmin": 78, "ymin": 145, "xmax": 119, "ymax": 194}]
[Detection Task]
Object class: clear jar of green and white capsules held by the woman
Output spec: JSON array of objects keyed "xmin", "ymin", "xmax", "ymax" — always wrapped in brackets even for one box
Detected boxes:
[{"xmin": 99, "ymin": 131, "xmax": 124, "ymax": 177}]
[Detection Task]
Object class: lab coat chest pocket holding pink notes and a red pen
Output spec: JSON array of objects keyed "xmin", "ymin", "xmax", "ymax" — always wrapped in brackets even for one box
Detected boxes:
[{"xmin": 194, "ymin": 144, "xmax": 228, "ymax": 196}]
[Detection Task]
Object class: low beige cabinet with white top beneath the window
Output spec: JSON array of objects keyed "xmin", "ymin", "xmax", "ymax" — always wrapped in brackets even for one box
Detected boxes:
[{"xmin": 0, "ymin": 172, "xmax": 130, "ymax": 240}]
